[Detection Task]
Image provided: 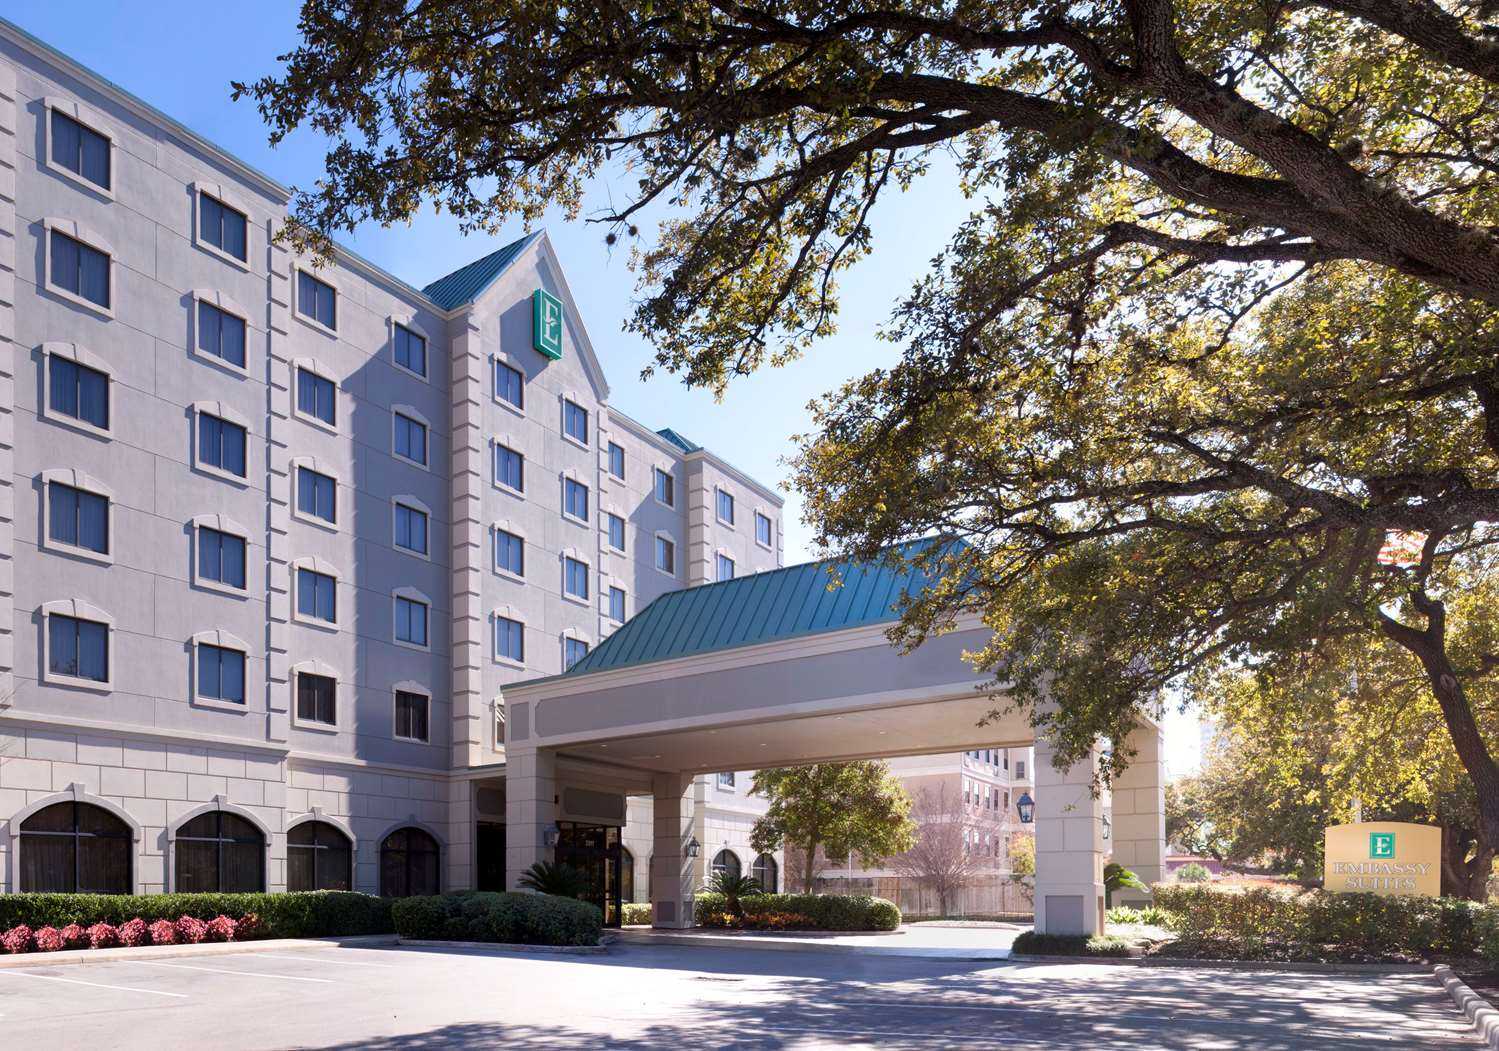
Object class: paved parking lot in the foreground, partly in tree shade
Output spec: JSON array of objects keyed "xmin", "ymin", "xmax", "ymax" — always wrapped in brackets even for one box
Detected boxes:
[{"xmin": 0, "ymin": 946, "xmax": 1480, "ymax": 1051}]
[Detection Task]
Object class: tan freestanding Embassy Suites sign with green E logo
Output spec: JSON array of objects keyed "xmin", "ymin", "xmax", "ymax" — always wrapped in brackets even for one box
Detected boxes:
[{"xmin": 1322, "ymin": 822, "xmax": 1442, "ymax": 898}]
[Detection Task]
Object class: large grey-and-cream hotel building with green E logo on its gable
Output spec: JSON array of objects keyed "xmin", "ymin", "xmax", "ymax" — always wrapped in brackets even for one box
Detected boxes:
[{"xmin": 0, "ymin": 22, "xmax": 781, "ymax": 897}]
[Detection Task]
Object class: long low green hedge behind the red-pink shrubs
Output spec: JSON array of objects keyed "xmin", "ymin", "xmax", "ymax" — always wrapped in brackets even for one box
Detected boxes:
[{"xmin": 0, "ymin": 891, "xmax": 396, "ymax": 939}]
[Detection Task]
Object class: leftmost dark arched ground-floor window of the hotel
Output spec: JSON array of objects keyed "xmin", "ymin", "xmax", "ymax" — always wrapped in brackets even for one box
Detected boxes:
[{"xmin": 21, "ymin": 802, "xmax": 135, "ymax": 894}]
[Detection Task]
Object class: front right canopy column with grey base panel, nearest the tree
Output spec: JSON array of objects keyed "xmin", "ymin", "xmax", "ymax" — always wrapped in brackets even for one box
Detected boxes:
[{"xmin": 1036, "ymin": 728, "xmax": 1103, "ymax": 934}]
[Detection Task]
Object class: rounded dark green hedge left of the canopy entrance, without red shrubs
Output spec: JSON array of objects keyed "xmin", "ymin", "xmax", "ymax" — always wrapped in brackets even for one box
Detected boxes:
[{"xmin": 391, "ymin": 891, "xmax": 604, "ymax": 945}]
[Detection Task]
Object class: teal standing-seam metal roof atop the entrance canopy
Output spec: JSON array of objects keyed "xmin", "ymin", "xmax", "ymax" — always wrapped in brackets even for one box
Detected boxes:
[{"xmin": 565, "ymin": 538, "xmax": 947, "ymax": 676}]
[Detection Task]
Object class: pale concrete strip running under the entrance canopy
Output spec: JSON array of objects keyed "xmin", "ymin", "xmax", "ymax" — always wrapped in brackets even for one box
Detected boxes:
[{"xmin": 615, "ymin": 924, "xmax": 1030, "ymax": 960}]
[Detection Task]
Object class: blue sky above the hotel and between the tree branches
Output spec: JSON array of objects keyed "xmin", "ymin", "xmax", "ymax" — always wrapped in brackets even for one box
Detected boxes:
[{"xmin": 4, "ymin": 0, "xmax": 1198, "ymax": 771}]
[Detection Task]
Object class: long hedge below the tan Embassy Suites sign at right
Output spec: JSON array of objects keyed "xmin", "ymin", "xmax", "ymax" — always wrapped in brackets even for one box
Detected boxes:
[{"xmin": 1151, "ymin": 883, "xmax": 1499, "ymax": 960}]
